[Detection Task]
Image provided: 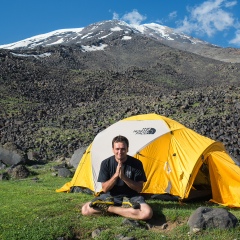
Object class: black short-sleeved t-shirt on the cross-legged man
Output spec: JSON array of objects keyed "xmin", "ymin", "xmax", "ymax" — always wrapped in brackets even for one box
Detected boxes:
[{"xmin": 98, "ymin": 156, "xmax": 147, "ymax": 197}]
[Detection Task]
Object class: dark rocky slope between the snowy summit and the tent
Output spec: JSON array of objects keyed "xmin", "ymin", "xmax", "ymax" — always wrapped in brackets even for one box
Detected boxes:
[{"xmin": 0, "ymin": 20, "xmax": 240, "ymax": 164}]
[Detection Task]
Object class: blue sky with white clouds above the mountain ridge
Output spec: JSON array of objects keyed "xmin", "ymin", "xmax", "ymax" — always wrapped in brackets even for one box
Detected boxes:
[{"xmin": 0, "ymin": 0, "xmax": 240, "ymax": 48}]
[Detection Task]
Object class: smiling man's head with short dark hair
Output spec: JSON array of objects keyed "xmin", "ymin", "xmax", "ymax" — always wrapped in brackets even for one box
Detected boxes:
[{"xmin": 112, "ymin": 135, "xmax": 129, "ymax": 162}]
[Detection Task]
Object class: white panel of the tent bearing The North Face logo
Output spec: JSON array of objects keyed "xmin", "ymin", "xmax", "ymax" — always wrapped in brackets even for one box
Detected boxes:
[{"xmin": 91, "ymin": 120, "xmax": 170, "ymax": 191}]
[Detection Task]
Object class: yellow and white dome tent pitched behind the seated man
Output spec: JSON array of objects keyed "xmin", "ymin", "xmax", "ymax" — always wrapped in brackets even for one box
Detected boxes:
[{"xmin": 57, "ymin": 114, "xmax": 240, "ymax": 207}]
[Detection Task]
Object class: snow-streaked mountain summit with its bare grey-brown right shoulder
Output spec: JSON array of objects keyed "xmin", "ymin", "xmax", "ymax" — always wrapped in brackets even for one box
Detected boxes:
[{"xmin": 0, "ymin": 20, "xmax": 240, "ymax": 62}]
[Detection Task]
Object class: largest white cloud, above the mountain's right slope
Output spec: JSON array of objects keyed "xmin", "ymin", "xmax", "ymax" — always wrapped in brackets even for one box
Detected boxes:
[{"xmin": 178, "ymin": 0, "xmax": 237, "ymax": 37}]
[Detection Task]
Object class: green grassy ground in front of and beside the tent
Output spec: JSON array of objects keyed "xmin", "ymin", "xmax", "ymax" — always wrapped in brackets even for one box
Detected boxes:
[{"xmin": 0, "ymin": 164, "xmax": 240, "ymax": 240}]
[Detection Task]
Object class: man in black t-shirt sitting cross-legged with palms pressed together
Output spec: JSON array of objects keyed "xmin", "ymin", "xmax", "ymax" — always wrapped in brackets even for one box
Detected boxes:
[{"xmin": 82, "ymin": 136, "xmax": 153, "ymax": 220}]
